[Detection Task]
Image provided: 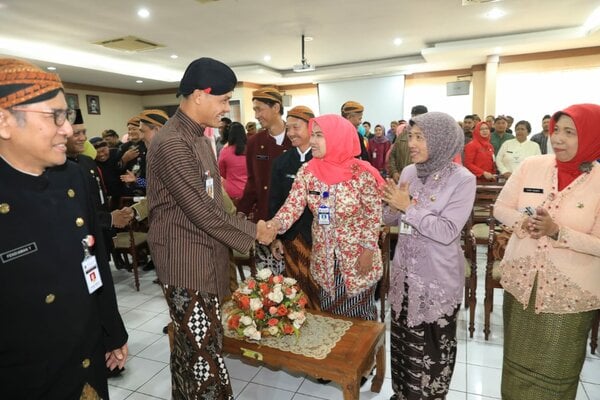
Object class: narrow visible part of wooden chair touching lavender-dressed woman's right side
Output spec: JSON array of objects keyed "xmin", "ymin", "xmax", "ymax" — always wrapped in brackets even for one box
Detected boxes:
[{"xmin": 461, "ymin": 213, "xmax": 477, "ymax": 337}]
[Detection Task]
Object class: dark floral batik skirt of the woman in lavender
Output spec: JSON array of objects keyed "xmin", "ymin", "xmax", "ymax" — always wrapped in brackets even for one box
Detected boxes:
[{"xmin": 390, "ymin": 282, "xmax": 459, "ymax": 400}]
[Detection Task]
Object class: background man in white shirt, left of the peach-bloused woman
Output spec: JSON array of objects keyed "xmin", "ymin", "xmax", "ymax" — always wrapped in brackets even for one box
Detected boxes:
[{"xmin": 496, "ymin": 121, "xmax": 541, "ymax": 179}]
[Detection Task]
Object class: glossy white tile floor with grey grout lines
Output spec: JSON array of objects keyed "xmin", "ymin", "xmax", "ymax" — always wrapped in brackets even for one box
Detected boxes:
[{"xmin": 109, "ymin": 249, "xmax": 600, "ymax": 400}]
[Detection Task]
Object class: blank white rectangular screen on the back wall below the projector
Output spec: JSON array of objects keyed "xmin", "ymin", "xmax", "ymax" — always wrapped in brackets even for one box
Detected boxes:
[{"xmin": 319, "ymin": 75, "xmax": 404, "ymax": 129}]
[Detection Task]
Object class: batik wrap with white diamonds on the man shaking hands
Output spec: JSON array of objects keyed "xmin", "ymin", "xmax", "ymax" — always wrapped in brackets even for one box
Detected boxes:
[{"xmin": 163, "ymin": 285, "xmax": 233, "ymax": 400}]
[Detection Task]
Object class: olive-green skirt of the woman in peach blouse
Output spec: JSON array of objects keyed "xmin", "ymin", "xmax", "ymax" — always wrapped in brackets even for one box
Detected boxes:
[{"xmin": 502, "ymin": 288, "xmax": 597, "ymax": 400}]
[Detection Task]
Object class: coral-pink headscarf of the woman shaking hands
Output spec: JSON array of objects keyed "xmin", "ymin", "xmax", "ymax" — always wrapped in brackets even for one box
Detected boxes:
[{"xmin": 306, "ymin": 114, "xmax": 385, "ymax": 186}]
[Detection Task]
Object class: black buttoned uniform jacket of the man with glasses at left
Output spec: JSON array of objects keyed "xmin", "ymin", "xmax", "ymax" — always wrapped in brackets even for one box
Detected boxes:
[{"xmin": 0, "ymin": 158, "xmax": 127, "ymax": 400}]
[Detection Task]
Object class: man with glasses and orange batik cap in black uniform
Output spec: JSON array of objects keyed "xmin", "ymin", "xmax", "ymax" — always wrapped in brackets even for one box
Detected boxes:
[{"xmin": 0, "ymin": 59, "xmax": 127, "ymax": 400}]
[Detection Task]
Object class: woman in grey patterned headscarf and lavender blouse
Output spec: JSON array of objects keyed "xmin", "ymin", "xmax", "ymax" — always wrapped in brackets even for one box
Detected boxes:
[{"xmin": 383, "ymin": 112, "xmax": 476, "ymax": 400}]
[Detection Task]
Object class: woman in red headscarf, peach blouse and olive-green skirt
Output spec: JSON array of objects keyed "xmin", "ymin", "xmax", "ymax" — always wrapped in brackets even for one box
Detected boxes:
[{"xmin": 494, "ymin": 104, "xmax": 600, "ymax": 400}]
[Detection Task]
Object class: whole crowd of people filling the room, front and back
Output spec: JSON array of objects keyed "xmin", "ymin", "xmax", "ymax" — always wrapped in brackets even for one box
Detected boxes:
[{"xmin": 0, "ymin": 54, "xmax": 600, "ymax": 400}]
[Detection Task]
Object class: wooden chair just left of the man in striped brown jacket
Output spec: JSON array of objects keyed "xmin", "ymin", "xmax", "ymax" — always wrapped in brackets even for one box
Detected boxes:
[{"xmin": 113, "ymin": 220, "xmax": 150, "ymax": 292}]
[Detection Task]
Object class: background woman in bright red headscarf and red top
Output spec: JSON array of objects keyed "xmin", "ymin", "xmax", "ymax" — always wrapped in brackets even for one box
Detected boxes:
[{"xmin": 464, "ymin": 122, "xmax": 496, "ymax": 181}]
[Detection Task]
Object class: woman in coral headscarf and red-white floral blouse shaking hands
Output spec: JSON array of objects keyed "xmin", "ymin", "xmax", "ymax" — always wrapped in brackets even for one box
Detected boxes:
[{"xmin": 270, "ymin": 115, "xmax": 385, "ymax": 320}]
